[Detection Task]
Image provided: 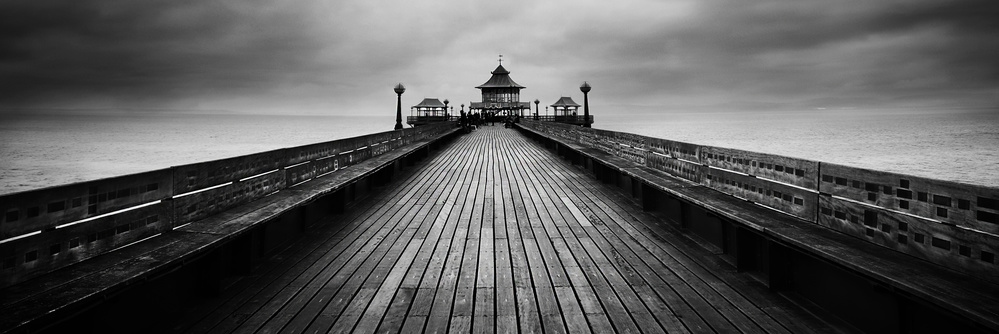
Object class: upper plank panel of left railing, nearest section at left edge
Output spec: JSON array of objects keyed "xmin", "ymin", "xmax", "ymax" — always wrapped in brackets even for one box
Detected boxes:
[{"xmin": 0, "ymin": 169, "xmax": 173, "ymax": 240}]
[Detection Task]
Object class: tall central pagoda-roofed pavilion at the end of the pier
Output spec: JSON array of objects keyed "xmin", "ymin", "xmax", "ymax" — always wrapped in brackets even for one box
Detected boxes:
[{"xmin": 468, "ymin": 60, "xmax": 531, "ymax": 118}]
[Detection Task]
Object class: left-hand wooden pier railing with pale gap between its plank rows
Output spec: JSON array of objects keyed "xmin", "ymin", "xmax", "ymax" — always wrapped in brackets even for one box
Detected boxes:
[{"xmin": 0, "ymin": 123, "xmax": 454, "ymax": 287}]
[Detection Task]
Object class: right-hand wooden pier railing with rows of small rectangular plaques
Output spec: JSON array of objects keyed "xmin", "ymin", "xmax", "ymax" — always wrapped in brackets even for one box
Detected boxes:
[{"xmin": 521, "ymin": 118, "xmax": 999, "ymax": 281}]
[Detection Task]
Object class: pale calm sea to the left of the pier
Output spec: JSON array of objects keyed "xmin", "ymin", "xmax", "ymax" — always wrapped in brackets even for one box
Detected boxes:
[{"xmin": 0, "ymin": 113, "xmax": 395, "ymax": 194}]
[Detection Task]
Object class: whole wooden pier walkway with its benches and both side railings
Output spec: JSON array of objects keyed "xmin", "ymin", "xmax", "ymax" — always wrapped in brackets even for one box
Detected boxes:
[{"xmin": 0, "ymin": 119, "xmax": 999, "ymax": 333}]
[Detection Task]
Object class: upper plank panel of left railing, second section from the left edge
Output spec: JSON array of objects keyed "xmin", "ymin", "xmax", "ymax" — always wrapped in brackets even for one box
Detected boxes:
[{"xmin": 173, "ymin": 149, "xmax": 285, "ymax": 195}]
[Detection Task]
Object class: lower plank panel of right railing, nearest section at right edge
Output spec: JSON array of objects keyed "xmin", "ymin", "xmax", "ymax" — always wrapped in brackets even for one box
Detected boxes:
[{"xmin": 818, "ymin": 195, "xmax": 999, "ymax": 281}]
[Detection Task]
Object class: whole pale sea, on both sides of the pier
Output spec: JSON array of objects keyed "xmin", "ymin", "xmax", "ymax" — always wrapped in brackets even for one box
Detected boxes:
[{"xmin": 0, "ymin": 109, "xmax": 999, "ymax": 194}]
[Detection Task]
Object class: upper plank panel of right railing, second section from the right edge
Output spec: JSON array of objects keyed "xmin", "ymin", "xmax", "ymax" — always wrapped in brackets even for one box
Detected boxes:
[{"xmin": 700, "ymin": 146, "xmax": 819, "ymax": 189}]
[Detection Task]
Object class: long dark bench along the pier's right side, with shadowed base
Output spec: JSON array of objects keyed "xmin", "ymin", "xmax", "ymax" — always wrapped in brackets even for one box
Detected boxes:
[{"xmin": 518, "ymin": 125, "xmax": 999, "ymax": 332}]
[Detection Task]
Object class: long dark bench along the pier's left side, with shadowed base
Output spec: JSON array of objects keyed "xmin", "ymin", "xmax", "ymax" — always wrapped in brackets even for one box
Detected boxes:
[{"xmin": 0, "ymin": 128, "xmax": 458, "ymax": 333}]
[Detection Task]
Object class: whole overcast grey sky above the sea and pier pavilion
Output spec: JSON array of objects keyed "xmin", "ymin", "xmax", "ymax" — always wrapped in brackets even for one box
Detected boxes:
[{"xmin": 0, "ymin": 0, "xmax": 999, "ymax": 115}]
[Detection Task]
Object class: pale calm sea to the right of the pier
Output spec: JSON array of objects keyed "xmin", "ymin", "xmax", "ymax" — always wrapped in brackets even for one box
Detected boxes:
[{"xmin": 594, "ymin": 110, "xmax": 999, "ymax": 187}]
